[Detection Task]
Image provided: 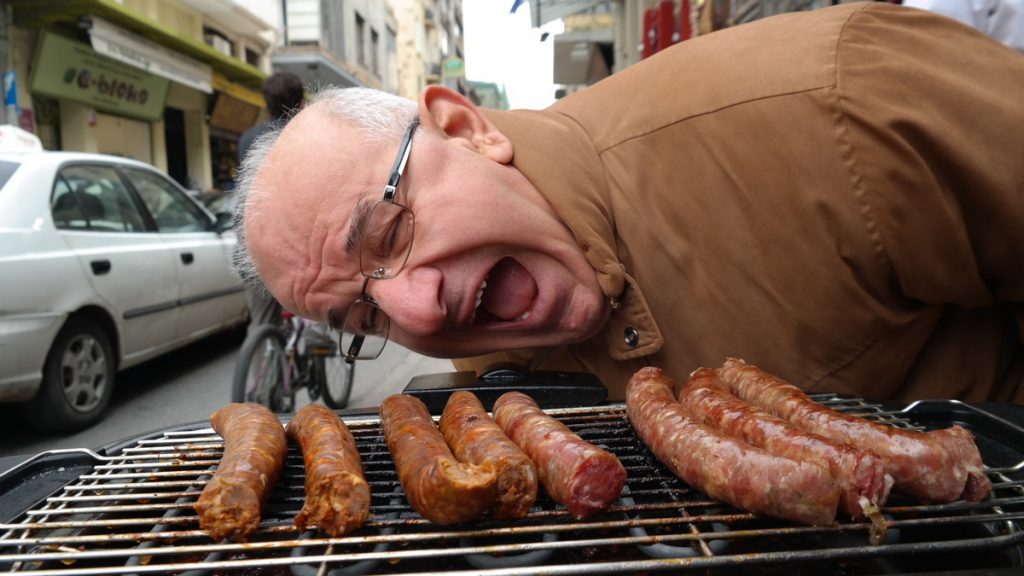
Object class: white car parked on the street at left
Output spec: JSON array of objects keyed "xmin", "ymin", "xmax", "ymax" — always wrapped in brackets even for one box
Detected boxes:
[{"xmin": 0, "ymin": 147, "xmax": 248, "ymax": 431}]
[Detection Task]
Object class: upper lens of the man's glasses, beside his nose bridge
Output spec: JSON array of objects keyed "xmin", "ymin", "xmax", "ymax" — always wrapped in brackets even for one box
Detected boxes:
[{"xmin": 359, "ymin": 202, "xmax": 416, "ymax": 280}]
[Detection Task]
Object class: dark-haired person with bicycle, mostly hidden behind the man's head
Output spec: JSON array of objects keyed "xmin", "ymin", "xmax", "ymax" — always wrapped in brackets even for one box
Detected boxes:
[{"xmin": 239, "ymin": 72, "xmax": 306, "ymax": 332}]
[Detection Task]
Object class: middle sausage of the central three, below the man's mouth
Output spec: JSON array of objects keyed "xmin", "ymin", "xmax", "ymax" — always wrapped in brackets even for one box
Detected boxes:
[{"xmin": 439, "ymin": 390, "xmax": 537, "ymax": 520}]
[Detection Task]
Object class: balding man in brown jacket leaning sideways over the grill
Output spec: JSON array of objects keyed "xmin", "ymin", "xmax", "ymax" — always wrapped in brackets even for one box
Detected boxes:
[{"xmin": 238, "ymin": 3, "xmax": 1024, "ymax": 402}]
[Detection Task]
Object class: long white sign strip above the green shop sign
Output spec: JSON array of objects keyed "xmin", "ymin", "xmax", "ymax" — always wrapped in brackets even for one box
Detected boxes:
[{"xmin": 89, "ymin": 16, "xmax": 213, "ymax": 94}]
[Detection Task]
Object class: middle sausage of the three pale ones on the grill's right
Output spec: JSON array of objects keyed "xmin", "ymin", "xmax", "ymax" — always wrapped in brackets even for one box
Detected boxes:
[{"xmin": 679, "ymin": 368, "xmax": 893, "ymax": 520}]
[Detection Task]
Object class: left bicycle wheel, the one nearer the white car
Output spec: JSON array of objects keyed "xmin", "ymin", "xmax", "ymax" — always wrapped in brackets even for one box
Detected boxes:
[{"xmin": 231, "ymin": 324, "xmax": 295, "ymax": 412}]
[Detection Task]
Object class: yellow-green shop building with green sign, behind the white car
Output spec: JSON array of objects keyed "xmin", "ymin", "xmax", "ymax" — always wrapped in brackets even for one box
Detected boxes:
[{"xmin": 2, "ymin": 0, "xmax": 275, "ymax": 190}]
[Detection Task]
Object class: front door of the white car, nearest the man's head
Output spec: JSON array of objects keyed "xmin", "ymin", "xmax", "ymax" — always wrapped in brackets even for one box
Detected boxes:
[{"xmin": 122, "ymin": 167, "xmax": 246, "ymax": 339}]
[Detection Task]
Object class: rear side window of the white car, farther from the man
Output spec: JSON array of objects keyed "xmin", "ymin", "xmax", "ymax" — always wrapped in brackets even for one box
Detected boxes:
[{"xmin": 50, "ymin": 164, "xmax": 145, "ymax": 232}]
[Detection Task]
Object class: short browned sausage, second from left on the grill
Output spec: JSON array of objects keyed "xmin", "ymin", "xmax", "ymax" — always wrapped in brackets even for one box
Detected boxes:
[{"xmin": 285, "ymin": 404, "xmax": 370, "ymax": 536}]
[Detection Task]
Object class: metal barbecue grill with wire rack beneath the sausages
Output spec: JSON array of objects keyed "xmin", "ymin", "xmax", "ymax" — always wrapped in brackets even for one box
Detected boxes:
[{"xmin": 0, "ymin": 395, "xmax": 1024, "ymax": 576}]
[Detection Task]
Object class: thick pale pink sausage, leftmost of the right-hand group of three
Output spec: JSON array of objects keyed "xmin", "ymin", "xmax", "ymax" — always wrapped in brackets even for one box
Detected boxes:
[{"xmin": 626, "ymin": 368, "xmax": 840, "ymax": 526}]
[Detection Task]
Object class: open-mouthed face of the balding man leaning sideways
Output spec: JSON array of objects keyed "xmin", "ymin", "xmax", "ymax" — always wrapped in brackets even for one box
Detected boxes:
[{"xmin": 246, "ymin": 108, "xmax": 608, "ymax": 357}]
